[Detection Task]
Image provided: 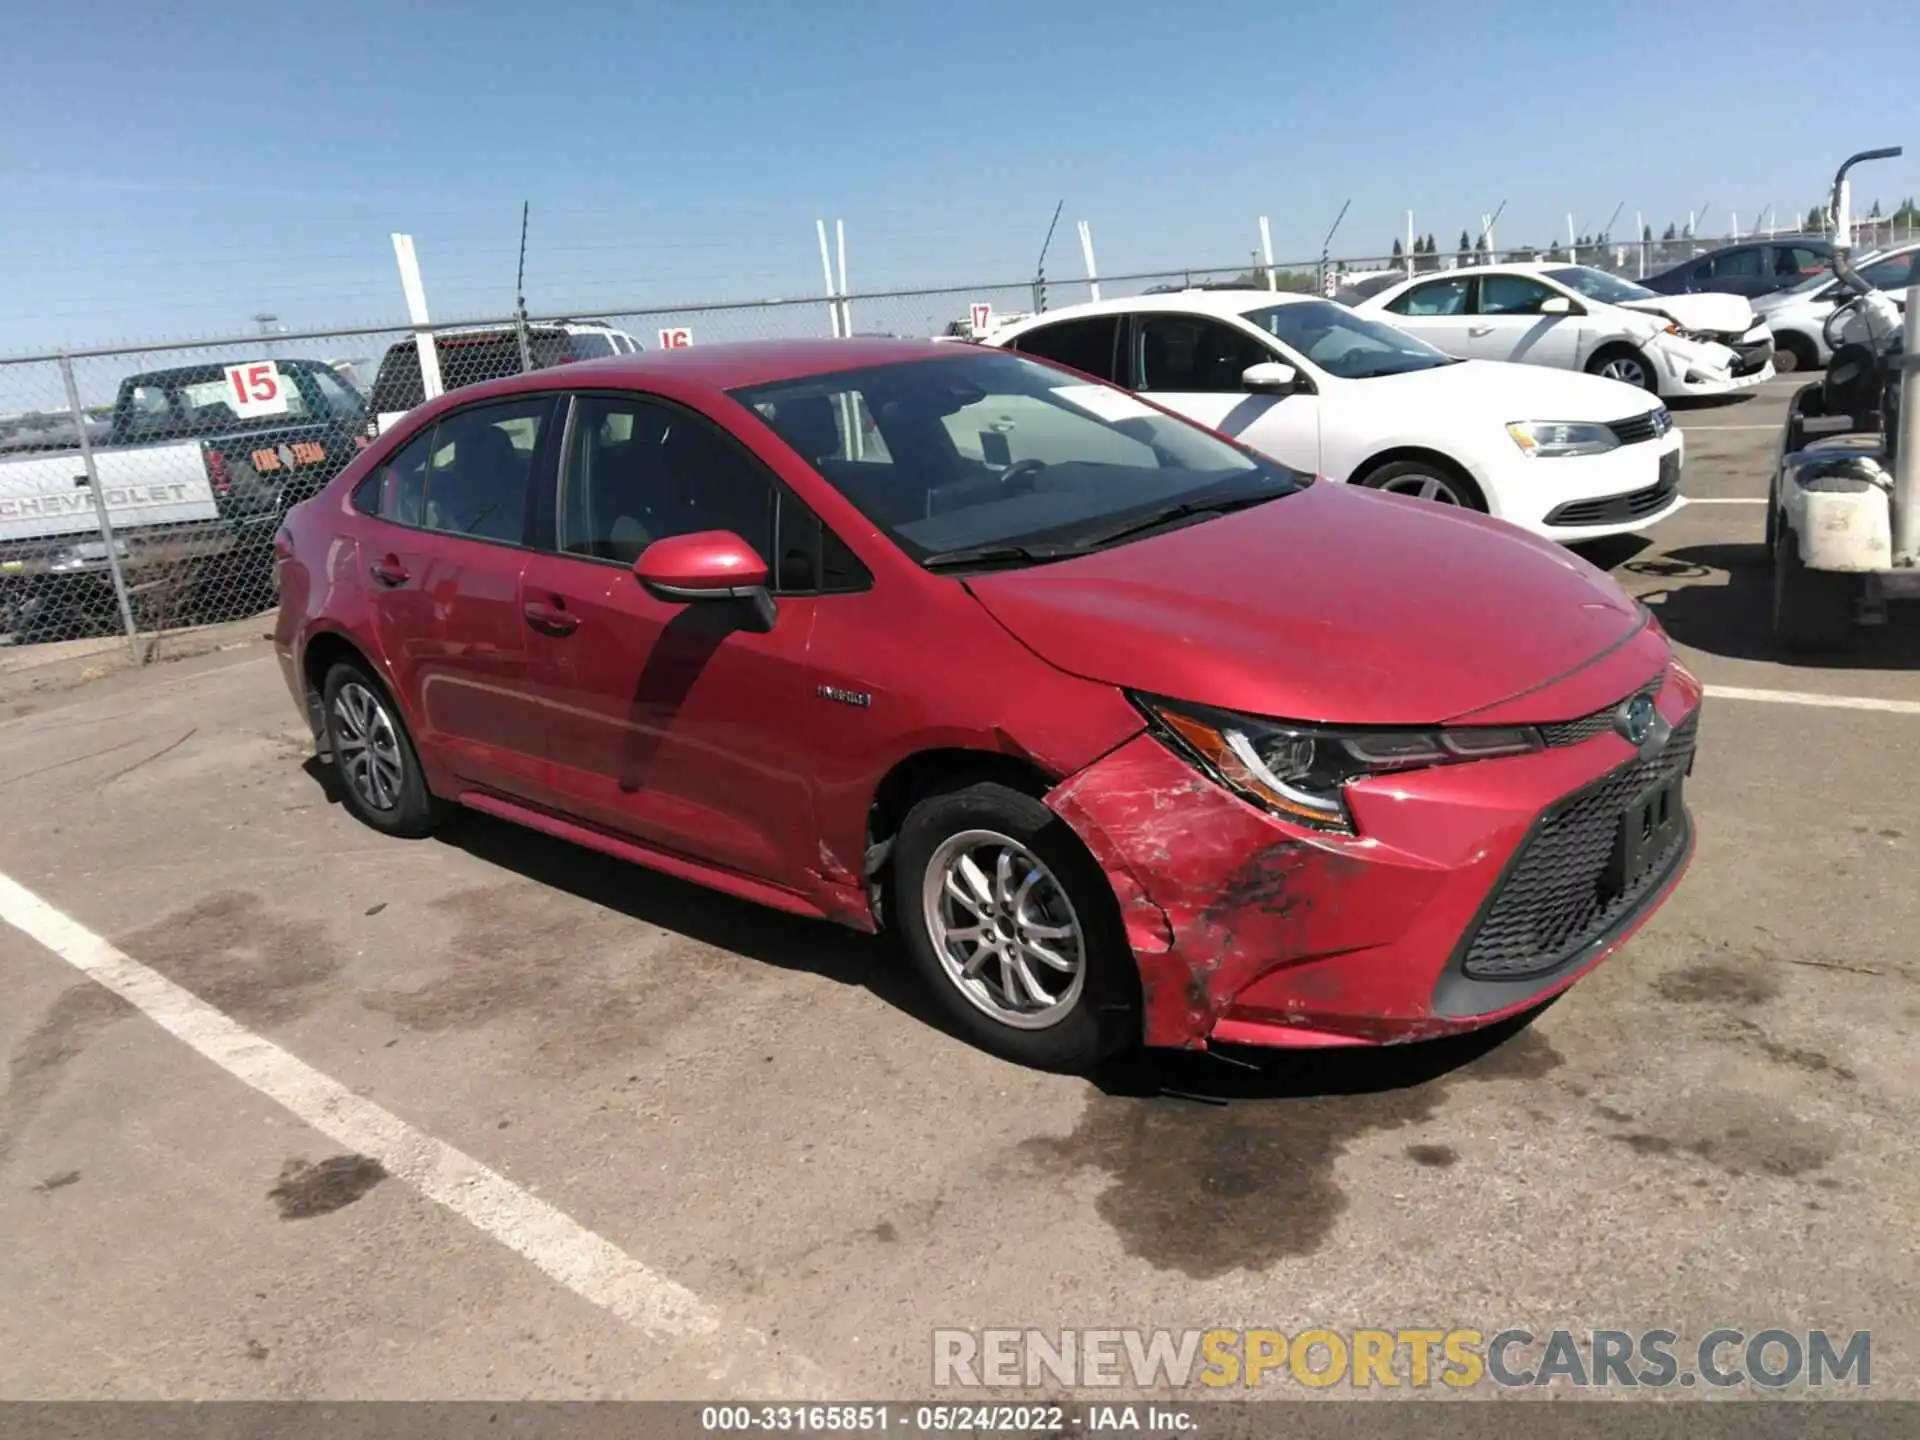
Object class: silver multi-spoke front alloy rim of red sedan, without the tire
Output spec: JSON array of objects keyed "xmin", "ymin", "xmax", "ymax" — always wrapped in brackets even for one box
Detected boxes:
[{"xmin": 922, "ymin": 829, "xmax": 1087, "ymax": 1029}]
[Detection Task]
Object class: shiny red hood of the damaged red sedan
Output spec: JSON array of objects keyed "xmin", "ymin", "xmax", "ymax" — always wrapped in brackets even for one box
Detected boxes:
[{"xmin": 966, "ymin": 480, "xmax": 1645, "ymax": 726}]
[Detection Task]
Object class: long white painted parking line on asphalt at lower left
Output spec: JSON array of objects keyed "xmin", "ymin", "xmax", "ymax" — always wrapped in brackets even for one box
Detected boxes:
[{"xmin": 0, "ymin": 876, "xmax": 831, "ymax": 1398}]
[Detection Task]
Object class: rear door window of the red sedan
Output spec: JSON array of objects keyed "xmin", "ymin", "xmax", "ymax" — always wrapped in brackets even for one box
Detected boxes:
[{"xmin": 412, "ymin": 396, "xmax": 553, "ymax": 545}]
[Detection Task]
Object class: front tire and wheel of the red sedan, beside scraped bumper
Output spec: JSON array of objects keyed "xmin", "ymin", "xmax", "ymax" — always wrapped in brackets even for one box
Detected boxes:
[{"xmin": 893, "ymin": 780, "xmax": 1140, "ymax": 1073}]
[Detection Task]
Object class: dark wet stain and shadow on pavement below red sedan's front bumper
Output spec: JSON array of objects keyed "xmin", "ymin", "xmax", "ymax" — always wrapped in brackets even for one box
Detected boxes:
[{"xmin": 1021, "ymin": 1027, "xmax": 1561, "ymax": 1279}]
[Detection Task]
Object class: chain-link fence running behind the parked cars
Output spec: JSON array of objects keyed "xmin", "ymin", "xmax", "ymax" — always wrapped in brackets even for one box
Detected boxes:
[{"xmin": 0, "ymin": 216, "xmax": 1899, "ymax": 659}]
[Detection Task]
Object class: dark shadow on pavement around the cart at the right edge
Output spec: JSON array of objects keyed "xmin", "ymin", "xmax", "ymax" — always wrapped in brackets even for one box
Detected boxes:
[{"xmin": 1622, "ymin": 543, "xmax": 1920, "ymax": 670}]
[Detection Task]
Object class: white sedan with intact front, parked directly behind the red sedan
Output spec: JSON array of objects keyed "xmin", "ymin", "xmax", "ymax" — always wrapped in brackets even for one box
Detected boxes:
[{"xmin": 987, "ymin": 290, "xmax": 1684, "ymax": 541}]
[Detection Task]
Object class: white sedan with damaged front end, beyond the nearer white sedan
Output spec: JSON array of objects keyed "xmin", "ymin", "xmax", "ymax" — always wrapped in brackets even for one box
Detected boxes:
[{"xmin": 1356, "ymin": 263, "xmax": 1774, "ymax": 399}]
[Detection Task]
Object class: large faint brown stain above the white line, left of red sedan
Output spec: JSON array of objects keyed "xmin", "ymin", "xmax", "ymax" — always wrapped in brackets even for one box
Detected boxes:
[{"xmin": 115, "ymin": 891, "xmax": 342, "ymax": 1025}]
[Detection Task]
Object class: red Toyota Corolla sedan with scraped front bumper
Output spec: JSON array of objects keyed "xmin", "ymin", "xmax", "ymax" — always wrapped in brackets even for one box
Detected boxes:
[{"xmin": 276, "ymin": 340, "xmax": 1701, "ymax": 1068}]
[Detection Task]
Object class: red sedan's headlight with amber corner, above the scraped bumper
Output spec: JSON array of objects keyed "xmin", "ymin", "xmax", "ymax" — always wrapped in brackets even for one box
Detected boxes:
[{"xmin": 1135, "ymin": 695, "xmax": 1542, "ymax": 835}]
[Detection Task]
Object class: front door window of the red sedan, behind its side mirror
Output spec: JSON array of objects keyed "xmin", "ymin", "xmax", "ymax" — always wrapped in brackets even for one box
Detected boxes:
[{"xmin": 561, "ymin": 396, "xmax": 776, "ymax": 564}]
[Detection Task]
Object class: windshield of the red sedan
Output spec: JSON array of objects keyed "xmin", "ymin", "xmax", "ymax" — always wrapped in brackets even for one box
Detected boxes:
[{"xmin": 733, "ymin": 349, "xmax": 1309, "ymax": 563}]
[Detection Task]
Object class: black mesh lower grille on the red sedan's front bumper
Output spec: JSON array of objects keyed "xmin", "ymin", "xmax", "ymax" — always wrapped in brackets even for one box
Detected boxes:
[{"xmin": 1461, "ymin": 708, "xmax": 1699, "ymax": 979}]
